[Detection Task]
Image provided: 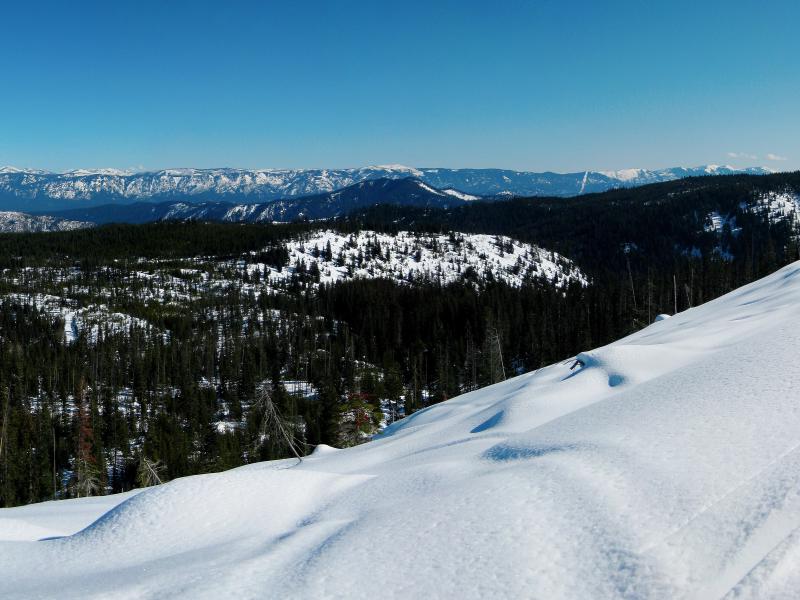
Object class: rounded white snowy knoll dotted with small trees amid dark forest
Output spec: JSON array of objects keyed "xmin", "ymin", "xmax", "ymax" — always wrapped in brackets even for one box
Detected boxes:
[{"xmin": 262, "ymin": 231, "xmax": 587, "ymax": 287}]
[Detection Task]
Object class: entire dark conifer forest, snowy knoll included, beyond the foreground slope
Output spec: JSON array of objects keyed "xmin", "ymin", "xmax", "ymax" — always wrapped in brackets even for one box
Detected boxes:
[{"xmin": 0, "ymin": 174, "xmax": 800, "ymax": 506}]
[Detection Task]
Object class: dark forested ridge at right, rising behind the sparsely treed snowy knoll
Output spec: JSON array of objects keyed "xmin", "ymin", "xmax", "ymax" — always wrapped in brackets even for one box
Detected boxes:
[{"xmin": 344, "ymin": 172, "xmax": 800, "ymax": 270}]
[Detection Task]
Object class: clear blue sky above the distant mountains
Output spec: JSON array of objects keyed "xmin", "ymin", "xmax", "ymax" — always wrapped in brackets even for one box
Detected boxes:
[{"xmin": 0, "ymin": 0, "xmax": 800, "ymax": 171}]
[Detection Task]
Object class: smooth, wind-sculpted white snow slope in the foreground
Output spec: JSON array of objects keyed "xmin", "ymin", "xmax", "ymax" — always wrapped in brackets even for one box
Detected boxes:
[{"xmin": 0, "ymin": 263, "xmax": 800, "ymax": 599}]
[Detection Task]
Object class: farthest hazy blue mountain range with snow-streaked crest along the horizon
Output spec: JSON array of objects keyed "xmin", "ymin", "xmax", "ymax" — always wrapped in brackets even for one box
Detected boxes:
[{"xmin": 0, "ymin": 165, "xmax": 769, "ymax": 211}]
